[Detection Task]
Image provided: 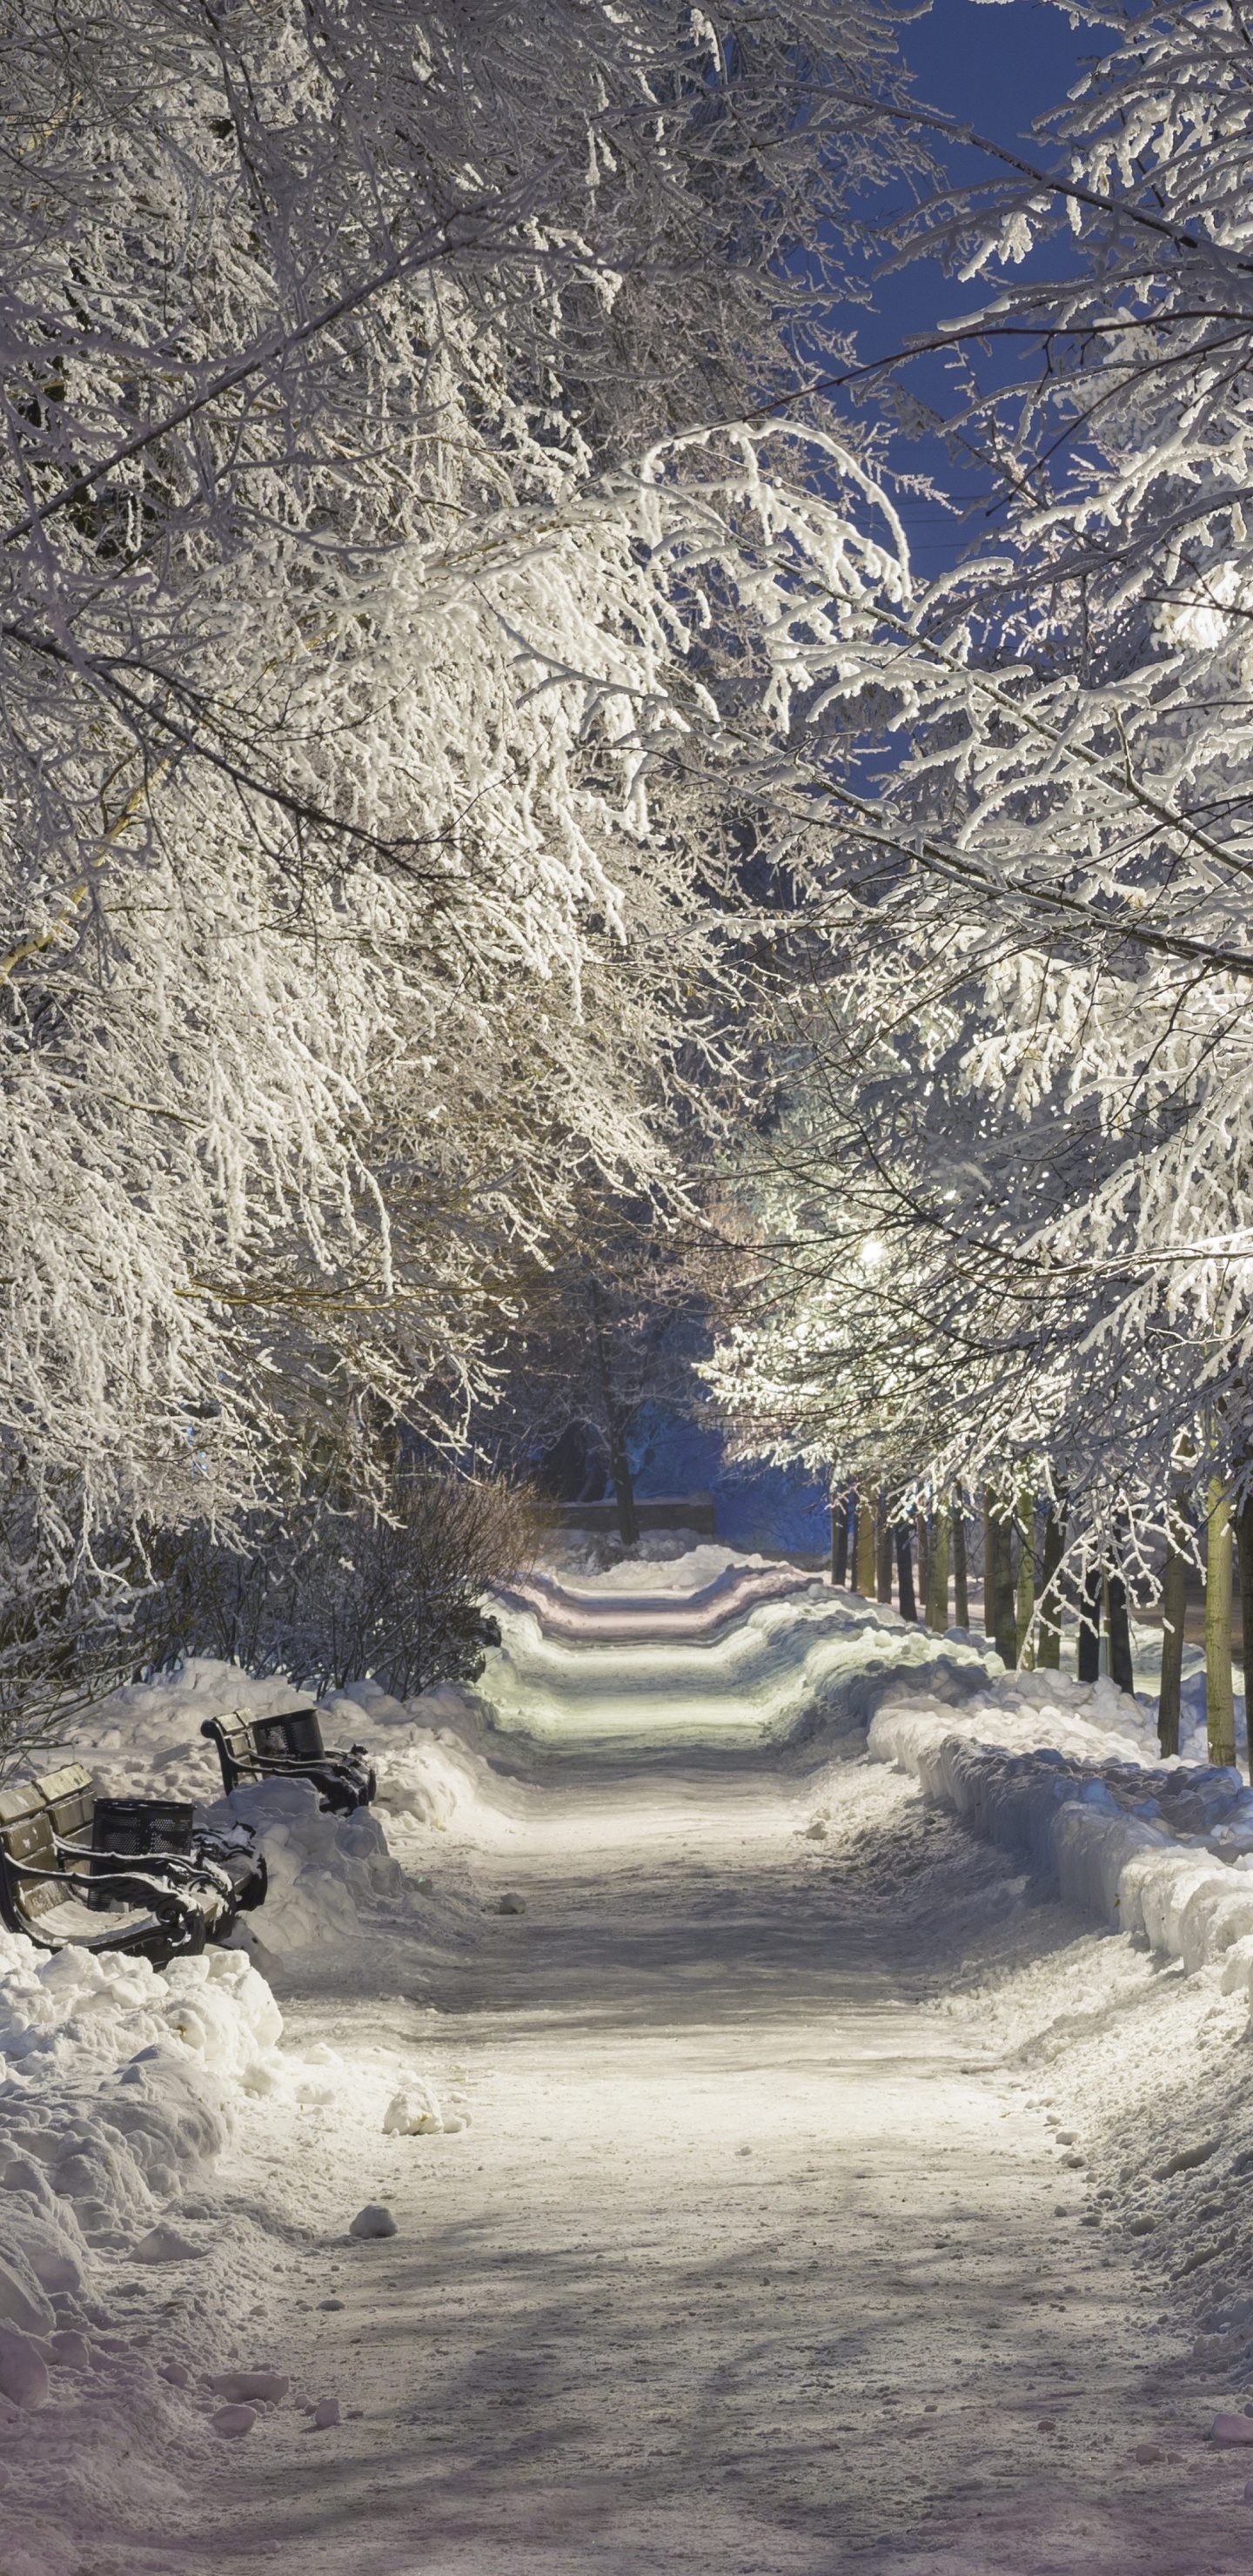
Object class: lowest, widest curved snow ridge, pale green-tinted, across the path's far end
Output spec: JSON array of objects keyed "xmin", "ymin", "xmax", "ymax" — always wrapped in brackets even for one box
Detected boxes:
[{"xmin": 477, "ymin": 1587, "xmax": 990, "ymax": 1752}]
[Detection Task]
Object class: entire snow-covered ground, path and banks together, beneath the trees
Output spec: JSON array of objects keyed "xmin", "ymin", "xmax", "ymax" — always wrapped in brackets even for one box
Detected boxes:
[{"xmin": 0, "ymin": 1543, "xmax": 1253, "ymax": 2576}]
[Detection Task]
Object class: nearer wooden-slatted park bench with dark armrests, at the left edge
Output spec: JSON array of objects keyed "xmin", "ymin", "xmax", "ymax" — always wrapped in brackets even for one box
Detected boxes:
[{"xmin": 0, "ymin": 1762, "xmax": 265, "ymax": 1968}]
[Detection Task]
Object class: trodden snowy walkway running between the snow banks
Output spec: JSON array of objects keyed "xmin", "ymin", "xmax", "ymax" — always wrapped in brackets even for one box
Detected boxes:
[{"xmin": 176, "ymin": 1607, "xmax": 1253, "ymax": 2576}]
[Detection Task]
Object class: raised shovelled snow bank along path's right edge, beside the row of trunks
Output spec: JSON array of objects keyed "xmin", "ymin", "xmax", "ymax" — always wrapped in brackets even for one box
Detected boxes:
[{"xmin": 869, "ymin": 1674, "xmax": 1253, "ymax": 2002}]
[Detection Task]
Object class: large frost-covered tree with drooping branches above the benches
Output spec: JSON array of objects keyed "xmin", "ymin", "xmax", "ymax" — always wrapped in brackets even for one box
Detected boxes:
[{"xmin": 0, "ymin": 0, "xmax": 908, "ymax": 1587}]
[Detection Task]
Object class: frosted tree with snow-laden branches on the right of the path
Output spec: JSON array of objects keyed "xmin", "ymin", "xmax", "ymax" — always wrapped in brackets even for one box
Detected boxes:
[{"xmin": 706, "ymin": 5, "xmax": 1253, "ymax": 1587}]
